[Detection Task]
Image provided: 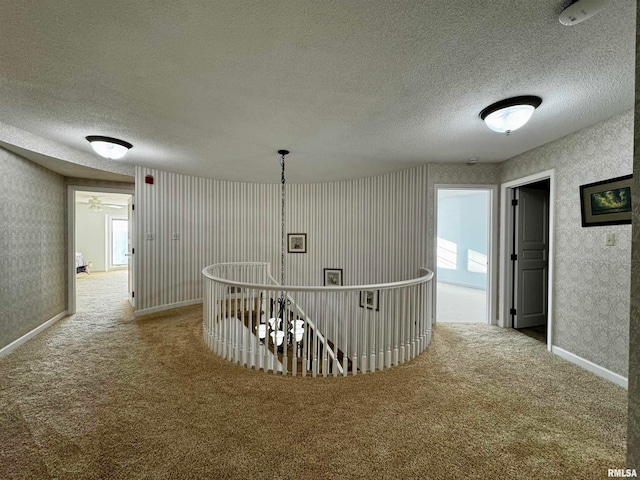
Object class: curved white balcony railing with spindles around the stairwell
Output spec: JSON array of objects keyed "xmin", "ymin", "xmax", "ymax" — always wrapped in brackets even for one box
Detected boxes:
[{"xmin": 202, "ymin": 262, "xmax": 433, "ymax": 377}]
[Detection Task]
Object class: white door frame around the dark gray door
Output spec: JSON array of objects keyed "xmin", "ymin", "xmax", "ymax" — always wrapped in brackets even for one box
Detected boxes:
[{"xmin": 498, "ymin": 169, "xmax": 556, "ymax": 351}]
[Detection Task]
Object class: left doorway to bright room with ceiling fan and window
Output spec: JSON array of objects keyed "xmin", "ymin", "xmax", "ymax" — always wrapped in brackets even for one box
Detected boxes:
[{"xmin": 68, "ymin": 186, "xmax": 134, "ymax": 313}]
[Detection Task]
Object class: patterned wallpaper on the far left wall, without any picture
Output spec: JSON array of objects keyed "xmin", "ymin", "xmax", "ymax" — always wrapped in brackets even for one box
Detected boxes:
[{"xmin": 0, "ymin": 148, "xmax": 67, "ymax": 348}]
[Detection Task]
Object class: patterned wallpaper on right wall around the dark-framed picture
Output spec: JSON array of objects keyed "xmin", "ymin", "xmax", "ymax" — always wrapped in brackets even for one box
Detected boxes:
[{"xmin": 501, "ymin": 111, "xmax": 633, "ymax": 377}]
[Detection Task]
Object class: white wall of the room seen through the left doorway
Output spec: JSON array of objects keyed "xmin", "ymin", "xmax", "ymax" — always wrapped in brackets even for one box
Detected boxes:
[{"xmin": 76, "ymin": 204, "xmax": 127, "ymax": 272}]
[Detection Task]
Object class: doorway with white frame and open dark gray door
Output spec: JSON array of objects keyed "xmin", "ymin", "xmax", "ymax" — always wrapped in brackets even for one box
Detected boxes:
[{"xmin": 498, "ymin": 170, "xmax": 555, "ymax": 350}]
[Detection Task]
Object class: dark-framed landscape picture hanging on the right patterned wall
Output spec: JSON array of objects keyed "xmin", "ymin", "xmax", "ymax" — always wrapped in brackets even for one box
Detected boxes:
[{"xmin": 580, "ymin": 175, "xmax": 633, "ymax": 227}]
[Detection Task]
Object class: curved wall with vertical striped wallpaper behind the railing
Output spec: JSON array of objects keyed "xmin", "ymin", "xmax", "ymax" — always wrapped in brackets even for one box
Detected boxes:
[{"xmin": 135, "ymin": 162, "xmax": 428, "ymax": 314}]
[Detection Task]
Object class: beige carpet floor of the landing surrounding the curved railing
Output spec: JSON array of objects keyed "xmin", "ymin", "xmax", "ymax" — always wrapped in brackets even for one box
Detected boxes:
[{"xmin": 0, "ymin": 272, "xmax": 626, "ymax": 479}]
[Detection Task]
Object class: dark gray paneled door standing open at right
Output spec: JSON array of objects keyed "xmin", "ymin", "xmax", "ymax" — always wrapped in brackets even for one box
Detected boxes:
[{"xmin": 512, "ymin": 187, "xmax": 549, "ymax": 328}]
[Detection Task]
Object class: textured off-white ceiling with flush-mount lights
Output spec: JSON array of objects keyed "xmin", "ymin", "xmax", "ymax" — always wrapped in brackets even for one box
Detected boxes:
[{"xmin": 0, "ymin": 0, "xmax": 636, "ymax": 182}]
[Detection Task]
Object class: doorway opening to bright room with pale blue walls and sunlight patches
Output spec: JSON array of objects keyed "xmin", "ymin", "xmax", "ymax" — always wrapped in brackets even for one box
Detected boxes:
[{"xmin": 434, "ymin": 185, "xmax": 497, "ymax": 323}]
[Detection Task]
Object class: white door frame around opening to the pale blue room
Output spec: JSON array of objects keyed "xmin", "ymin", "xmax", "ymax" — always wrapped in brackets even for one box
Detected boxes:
[{"xmin": 431, "ymin": 183, "xmax": 498, "ymax": 325}]
